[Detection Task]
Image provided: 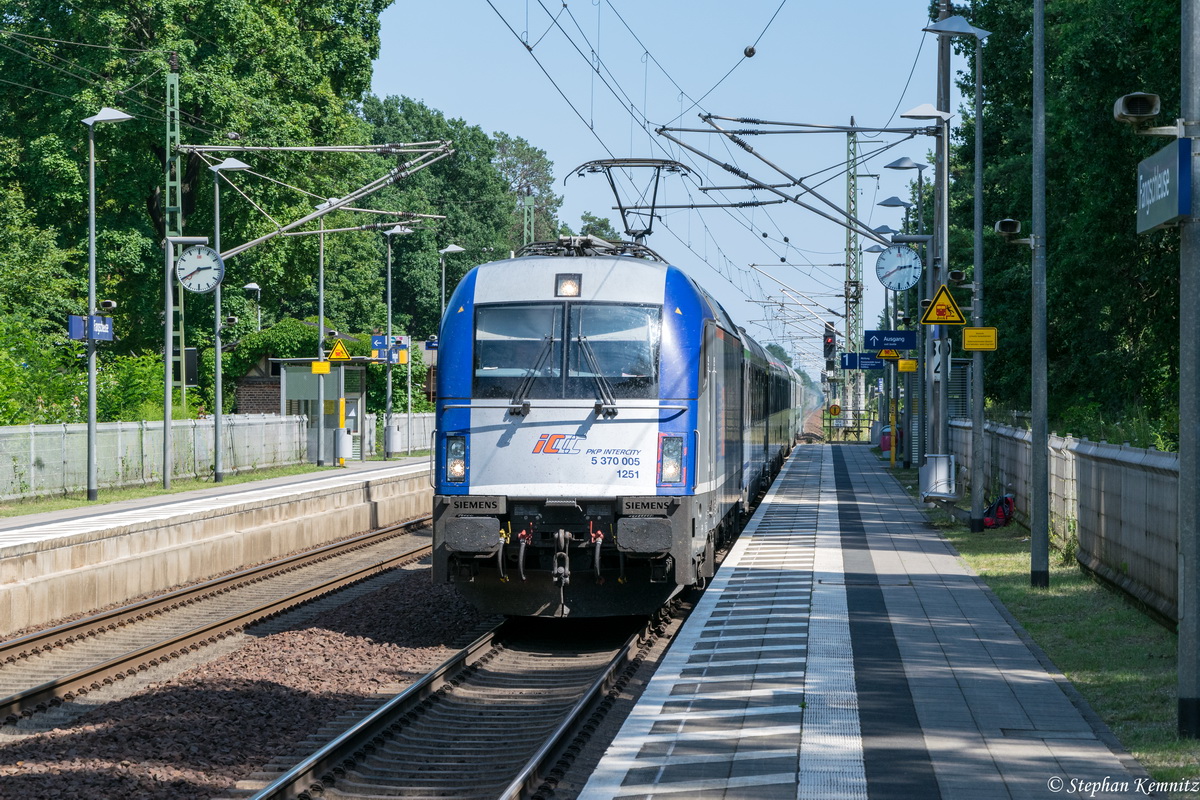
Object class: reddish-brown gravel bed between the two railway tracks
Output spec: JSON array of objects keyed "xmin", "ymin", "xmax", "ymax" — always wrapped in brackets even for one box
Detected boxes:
[{"xmin": 0, "ymin": 567, "xmax": 482, "ymax": 800}]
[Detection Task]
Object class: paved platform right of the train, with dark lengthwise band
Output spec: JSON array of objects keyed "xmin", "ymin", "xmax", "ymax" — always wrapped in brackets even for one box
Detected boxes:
[{"xmin": 578, "ymin": 445, "xmax": 1147, "ymax": 800}]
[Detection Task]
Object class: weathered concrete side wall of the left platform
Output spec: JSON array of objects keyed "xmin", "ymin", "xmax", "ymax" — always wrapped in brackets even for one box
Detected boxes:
[{"xmin": 0, "ymin": 470, "xmax": 433, "ymax": 636}]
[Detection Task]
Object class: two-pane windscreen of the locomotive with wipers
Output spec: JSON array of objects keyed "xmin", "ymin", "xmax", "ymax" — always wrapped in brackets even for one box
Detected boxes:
[{"xmin": 473, "ymin": 302, "xmax": 662, "ymax": 399}]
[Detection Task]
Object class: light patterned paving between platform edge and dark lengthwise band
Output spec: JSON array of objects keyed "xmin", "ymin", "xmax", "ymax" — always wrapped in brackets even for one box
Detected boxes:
[{"xmin": 580, "ymin": 447, "xmax": 866, "ymax": 800}]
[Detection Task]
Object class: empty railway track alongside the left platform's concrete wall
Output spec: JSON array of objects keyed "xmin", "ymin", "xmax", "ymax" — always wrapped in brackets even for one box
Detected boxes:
[{"xmin": 0, "ymin": 517, "xmax": 431, "ymax": 723}]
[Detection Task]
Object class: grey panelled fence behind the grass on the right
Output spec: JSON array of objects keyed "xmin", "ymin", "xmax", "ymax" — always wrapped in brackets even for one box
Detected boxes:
[{"xmin": 950, "ymin": 420, "xmax": 1180, "ymax": 619}]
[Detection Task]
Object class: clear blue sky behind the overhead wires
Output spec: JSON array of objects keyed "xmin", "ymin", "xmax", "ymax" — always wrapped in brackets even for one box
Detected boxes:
[{"xmin": 372, "ymin": 0, "xmax": 965, "ymax": 375}]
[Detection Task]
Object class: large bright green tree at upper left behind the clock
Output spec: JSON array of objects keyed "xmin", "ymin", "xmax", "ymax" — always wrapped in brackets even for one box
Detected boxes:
[{"xmin": 0, "ymin": 0, "xmax": 390, "ymax": 353}]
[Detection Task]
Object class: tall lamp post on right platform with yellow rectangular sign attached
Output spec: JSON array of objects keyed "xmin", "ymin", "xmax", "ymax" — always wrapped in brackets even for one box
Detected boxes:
[{"xmin": 924, "ymin": 17, "xmax": 990, "ymax": 533}]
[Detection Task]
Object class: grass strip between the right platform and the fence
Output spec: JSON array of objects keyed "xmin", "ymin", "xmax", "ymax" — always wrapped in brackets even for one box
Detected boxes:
[{"xmin": 884, "ymin": 460, "xmax": 1200, "ymax": 796}]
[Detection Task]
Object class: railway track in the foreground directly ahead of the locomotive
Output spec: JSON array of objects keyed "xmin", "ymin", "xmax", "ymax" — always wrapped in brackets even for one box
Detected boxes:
[{"xmin": 234, "ymin": 612, "xmax": 666, "ymax": 800}]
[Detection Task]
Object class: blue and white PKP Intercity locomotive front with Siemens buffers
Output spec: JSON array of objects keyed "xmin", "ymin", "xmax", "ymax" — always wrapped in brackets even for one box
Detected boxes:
[{"xmin": 433, "ymin": 255, "xmax": 712, "ymax": 616}]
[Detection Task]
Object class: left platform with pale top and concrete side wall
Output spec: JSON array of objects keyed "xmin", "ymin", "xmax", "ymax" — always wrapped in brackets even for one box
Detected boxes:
[{"xmin": 0, "ymin": 457, "xmax": 432, "ymax": 638}]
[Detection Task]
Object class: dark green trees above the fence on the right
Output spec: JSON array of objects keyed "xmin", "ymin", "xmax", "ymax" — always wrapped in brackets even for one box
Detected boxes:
[{"xmin": 950, "ymin": 0, "xmax": 1180, "ymax": 443}]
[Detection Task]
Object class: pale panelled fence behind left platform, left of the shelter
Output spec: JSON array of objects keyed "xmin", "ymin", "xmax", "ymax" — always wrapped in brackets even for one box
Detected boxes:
[{"xmin": 0, "ymin": 414, "xmax": 308, "ymax": 500}]
